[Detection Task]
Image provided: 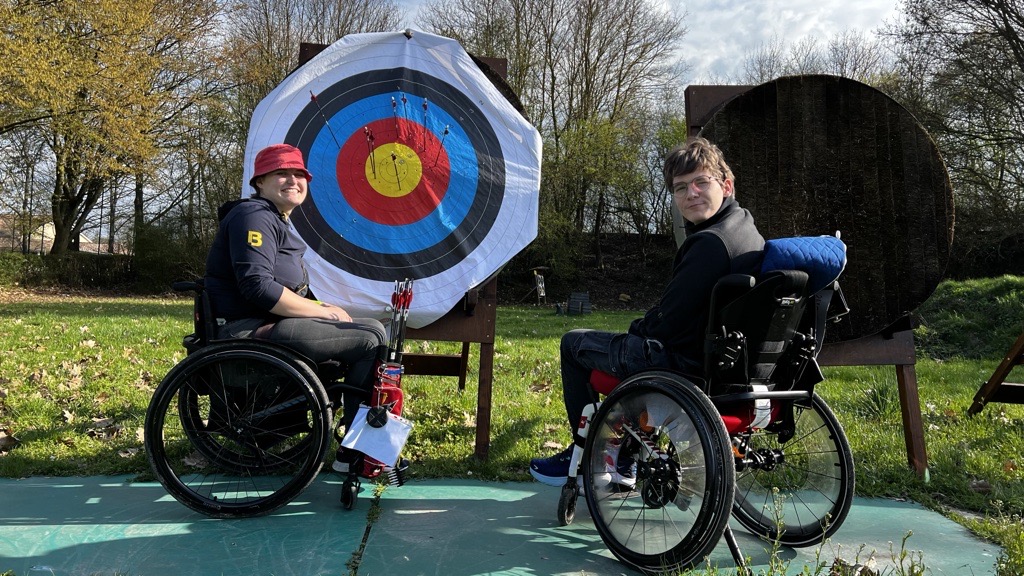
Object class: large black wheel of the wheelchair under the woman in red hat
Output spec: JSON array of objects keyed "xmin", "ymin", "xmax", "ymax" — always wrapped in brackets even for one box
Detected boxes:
[{"xmin": 144, "ymin": 340, "xmax": 331, "ymax": 518}]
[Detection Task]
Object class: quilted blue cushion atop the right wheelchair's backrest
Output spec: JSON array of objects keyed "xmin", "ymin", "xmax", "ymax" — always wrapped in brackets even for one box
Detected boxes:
[{"xmin": 761, "ymin": 236, "xmax": 846, "ymax": 294}]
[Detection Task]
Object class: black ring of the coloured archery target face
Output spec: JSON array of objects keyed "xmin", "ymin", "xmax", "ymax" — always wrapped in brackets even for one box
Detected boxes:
[{"xmin": 285, "ymin": 68, "xmax": 505, "ymax": 282}]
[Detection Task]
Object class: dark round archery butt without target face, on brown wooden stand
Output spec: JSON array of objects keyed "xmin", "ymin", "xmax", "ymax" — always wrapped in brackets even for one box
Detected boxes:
[{"xmin": 677, "ymin": 79, "xmax": 952, "ymax": 480}]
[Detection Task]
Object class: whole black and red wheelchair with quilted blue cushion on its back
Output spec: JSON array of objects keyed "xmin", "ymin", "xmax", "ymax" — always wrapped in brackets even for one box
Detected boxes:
[{"xmin": 558, "ymin": 231, "xmax": 854, "ymax": 573}]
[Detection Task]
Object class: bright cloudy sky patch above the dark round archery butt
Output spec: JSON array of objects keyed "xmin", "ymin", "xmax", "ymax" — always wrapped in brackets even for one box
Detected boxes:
[{"xmin": 398, "ymin": 0, "xmax": 898, "ymax": 84}]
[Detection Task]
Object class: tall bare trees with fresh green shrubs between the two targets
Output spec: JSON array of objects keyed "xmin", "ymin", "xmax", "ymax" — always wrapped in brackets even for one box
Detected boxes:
[{"xmin": 421, "ymin": 0, "xmax": 686, "ymax": 270}]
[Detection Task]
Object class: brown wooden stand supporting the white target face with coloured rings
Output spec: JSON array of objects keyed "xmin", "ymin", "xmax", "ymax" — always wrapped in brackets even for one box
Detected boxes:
[{"xmin": 299, "ymin": 42, "xmax": 509, "ymax": 460}]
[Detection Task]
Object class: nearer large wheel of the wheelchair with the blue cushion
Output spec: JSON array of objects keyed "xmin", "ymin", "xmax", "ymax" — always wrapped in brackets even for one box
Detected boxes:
[{"xmin": 583, "ymin": 371, "xmax": 735, "ymax": 574}]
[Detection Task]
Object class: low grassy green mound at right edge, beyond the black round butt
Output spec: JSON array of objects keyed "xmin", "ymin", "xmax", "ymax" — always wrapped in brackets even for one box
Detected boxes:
[{"xmin": 914, "ymin": 276, "xmax": 1024, "ymax": 360}]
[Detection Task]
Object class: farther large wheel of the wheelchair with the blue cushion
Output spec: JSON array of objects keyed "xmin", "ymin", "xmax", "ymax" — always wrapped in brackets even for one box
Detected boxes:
[{"xmin": 733, "ymin": 395, "xmax": 854, "ymax": 547}]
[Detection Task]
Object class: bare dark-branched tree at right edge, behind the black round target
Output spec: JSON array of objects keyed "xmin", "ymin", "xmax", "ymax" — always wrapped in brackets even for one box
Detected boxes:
[{"xmin": 886, "ymin": 0, "xmax": 1024, "ymax": 274}]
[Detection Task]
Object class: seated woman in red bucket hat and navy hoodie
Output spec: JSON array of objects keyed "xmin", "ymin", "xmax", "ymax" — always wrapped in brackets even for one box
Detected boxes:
[{"xmin": 205, "ymin": 143, "xmax": 386, "ymax": 471}]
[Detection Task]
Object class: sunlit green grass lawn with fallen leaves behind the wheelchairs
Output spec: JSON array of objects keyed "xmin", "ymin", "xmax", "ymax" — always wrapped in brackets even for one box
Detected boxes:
[{"xmin": 0, "ymin": 279, "xmax": 1024, "ymax": 575}]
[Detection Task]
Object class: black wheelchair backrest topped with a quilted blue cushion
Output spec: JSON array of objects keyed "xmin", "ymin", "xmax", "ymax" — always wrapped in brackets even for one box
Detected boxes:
[{"xmin": 705, "ymin": 231, "xmax": 846, "ymax": 389}]
